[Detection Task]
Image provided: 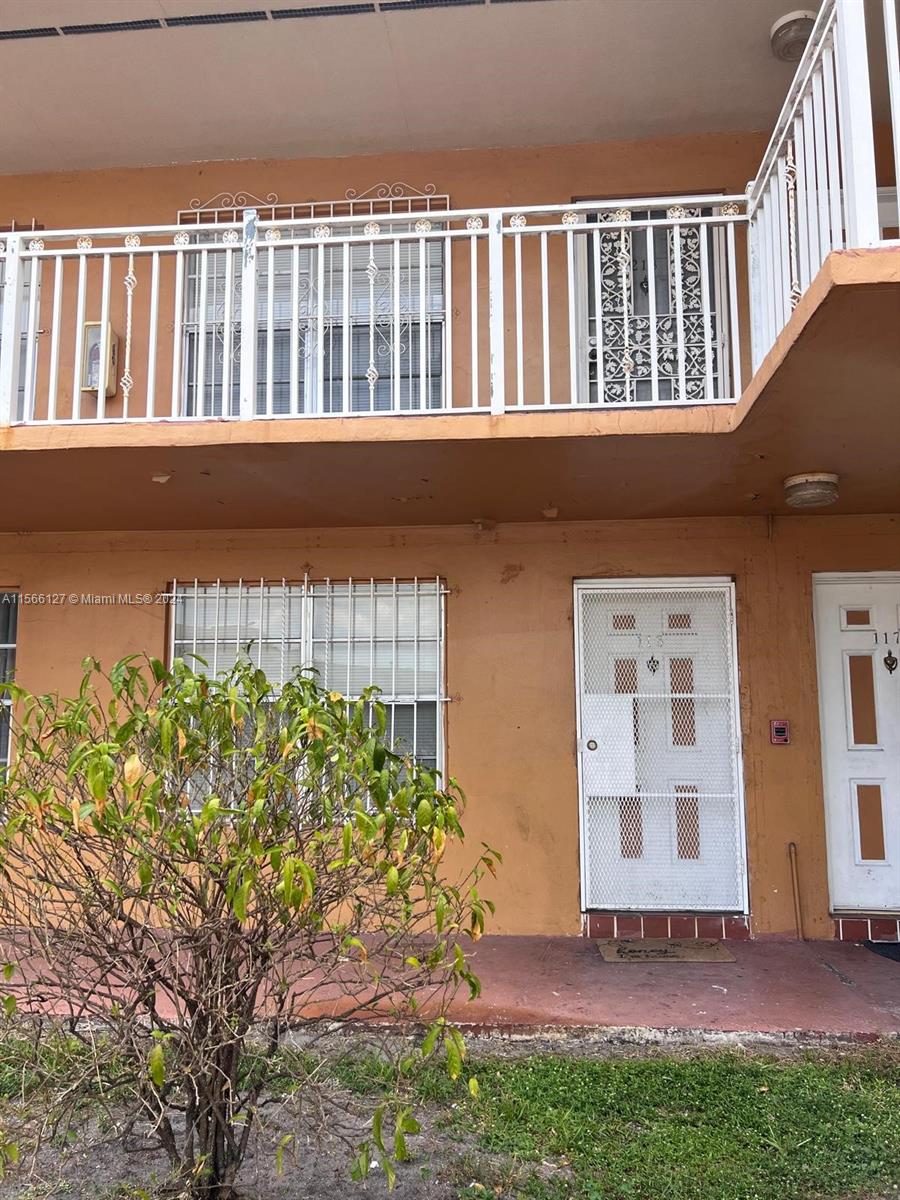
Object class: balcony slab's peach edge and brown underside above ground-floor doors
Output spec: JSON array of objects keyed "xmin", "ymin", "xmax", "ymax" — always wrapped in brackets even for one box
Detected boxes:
[{"xmin": 0, "ymin": 247, "xmax": 900, "ymax": 533}]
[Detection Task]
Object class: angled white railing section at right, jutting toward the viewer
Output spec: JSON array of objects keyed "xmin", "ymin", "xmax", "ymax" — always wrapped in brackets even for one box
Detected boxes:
[{"xmin": 748, "ymin": 0, "xmax": 900, "ymax": 370}]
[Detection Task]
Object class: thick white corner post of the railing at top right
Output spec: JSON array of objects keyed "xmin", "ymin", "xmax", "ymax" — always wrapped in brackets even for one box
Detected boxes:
[{"xmin": 835, "ymin": 0, "xmax": 881, "ymax": 246}]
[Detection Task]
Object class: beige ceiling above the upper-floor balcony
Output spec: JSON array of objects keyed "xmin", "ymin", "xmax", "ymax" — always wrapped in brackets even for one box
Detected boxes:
[{"xmin": 0, "ymin": 0, "xmax": 801, "ymax": 174}]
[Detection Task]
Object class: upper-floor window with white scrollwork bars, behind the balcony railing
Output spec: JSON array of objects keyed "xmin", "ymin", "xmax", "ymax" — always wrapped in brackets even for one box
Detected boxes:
[{"xmin": 184, "ymin": 224, "xmax": 445, "ymax": 416}]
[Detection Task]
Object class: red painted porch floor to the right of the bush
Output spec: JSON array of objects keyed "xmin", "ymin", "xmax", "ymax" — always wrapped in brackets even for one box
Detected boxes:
[{"xmin": 452, "ymin": 936, "xmax": 900, "ymax": 1039}]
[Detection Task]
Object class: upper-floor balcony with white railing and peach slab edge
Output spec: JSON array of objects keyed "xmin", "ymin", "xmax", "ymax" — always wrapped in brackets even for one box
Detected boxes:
[{"xmin": 0, "ymin": 0, "xmax": 900, "ymax": 523}]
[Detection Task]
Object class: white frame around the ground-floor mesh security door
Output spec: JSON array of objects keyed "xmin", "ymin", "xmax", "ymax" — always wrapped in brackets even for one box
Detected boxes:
[{"xmin": 572, "ymin": 575, "xmax": 750, "ymax": 919}]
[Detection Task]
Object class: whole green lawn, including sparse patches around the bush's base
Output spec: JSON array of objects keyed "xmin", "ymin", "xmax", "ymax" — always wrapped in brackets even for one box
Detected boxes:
[{"xmin": 0, "ymin": 1039, "xmax": 900, "ymax": 1200}]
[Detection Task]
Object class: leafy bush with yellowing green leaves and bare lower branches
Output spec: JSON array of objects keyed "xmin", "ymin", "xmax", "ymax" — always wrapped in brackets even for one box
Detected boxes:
[{"xmin": 0, "ymin": 658, "xmax": 498, "ymax": 1200}]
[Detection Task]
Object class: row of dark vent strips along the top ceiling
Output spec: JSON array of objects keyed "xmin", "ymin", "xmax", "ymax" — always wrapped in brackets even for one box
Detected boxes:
[{"xmin": 0, "ymin": 0, "xmax": 547, "ymax": 42}]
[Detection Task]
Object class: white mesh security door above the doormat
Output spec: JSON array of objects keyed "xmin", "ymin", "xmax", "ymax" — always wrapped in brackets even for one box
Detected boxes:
[{"xmin": 575, "ymin": 580, "xmax": 746, "ymax": 912}]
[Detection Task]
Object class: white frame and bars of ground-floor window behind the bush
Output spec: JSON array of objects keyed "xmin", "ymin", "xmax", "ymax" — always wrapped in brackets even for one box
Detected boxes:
[{"xmin": 168, "ymin": 576, "xmax": 449, "ymax": 778}]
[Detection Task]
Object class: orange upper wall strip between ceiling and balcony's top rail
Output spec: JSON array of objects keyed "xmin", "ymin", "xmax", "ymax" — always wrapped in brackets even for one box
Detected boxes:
[{"xmin": 0, "ymin": 133, "xmax": 767, "ymax": 229}]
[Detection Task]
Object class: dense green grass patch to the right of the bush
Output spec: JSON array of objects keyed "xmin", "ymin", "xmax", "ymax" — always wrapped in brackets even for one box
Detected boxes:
[{"xmin": 333, "ymin": 1048, "xmax": 900, "ymax": 1200}]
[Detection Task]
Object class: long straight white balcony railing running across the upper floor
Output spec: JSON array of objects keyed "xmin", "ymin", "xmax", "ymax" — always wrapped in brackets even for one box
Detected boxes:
[{"xmin": 0, "ymin": 196, "xmax": 745, "ymax": 424}]
